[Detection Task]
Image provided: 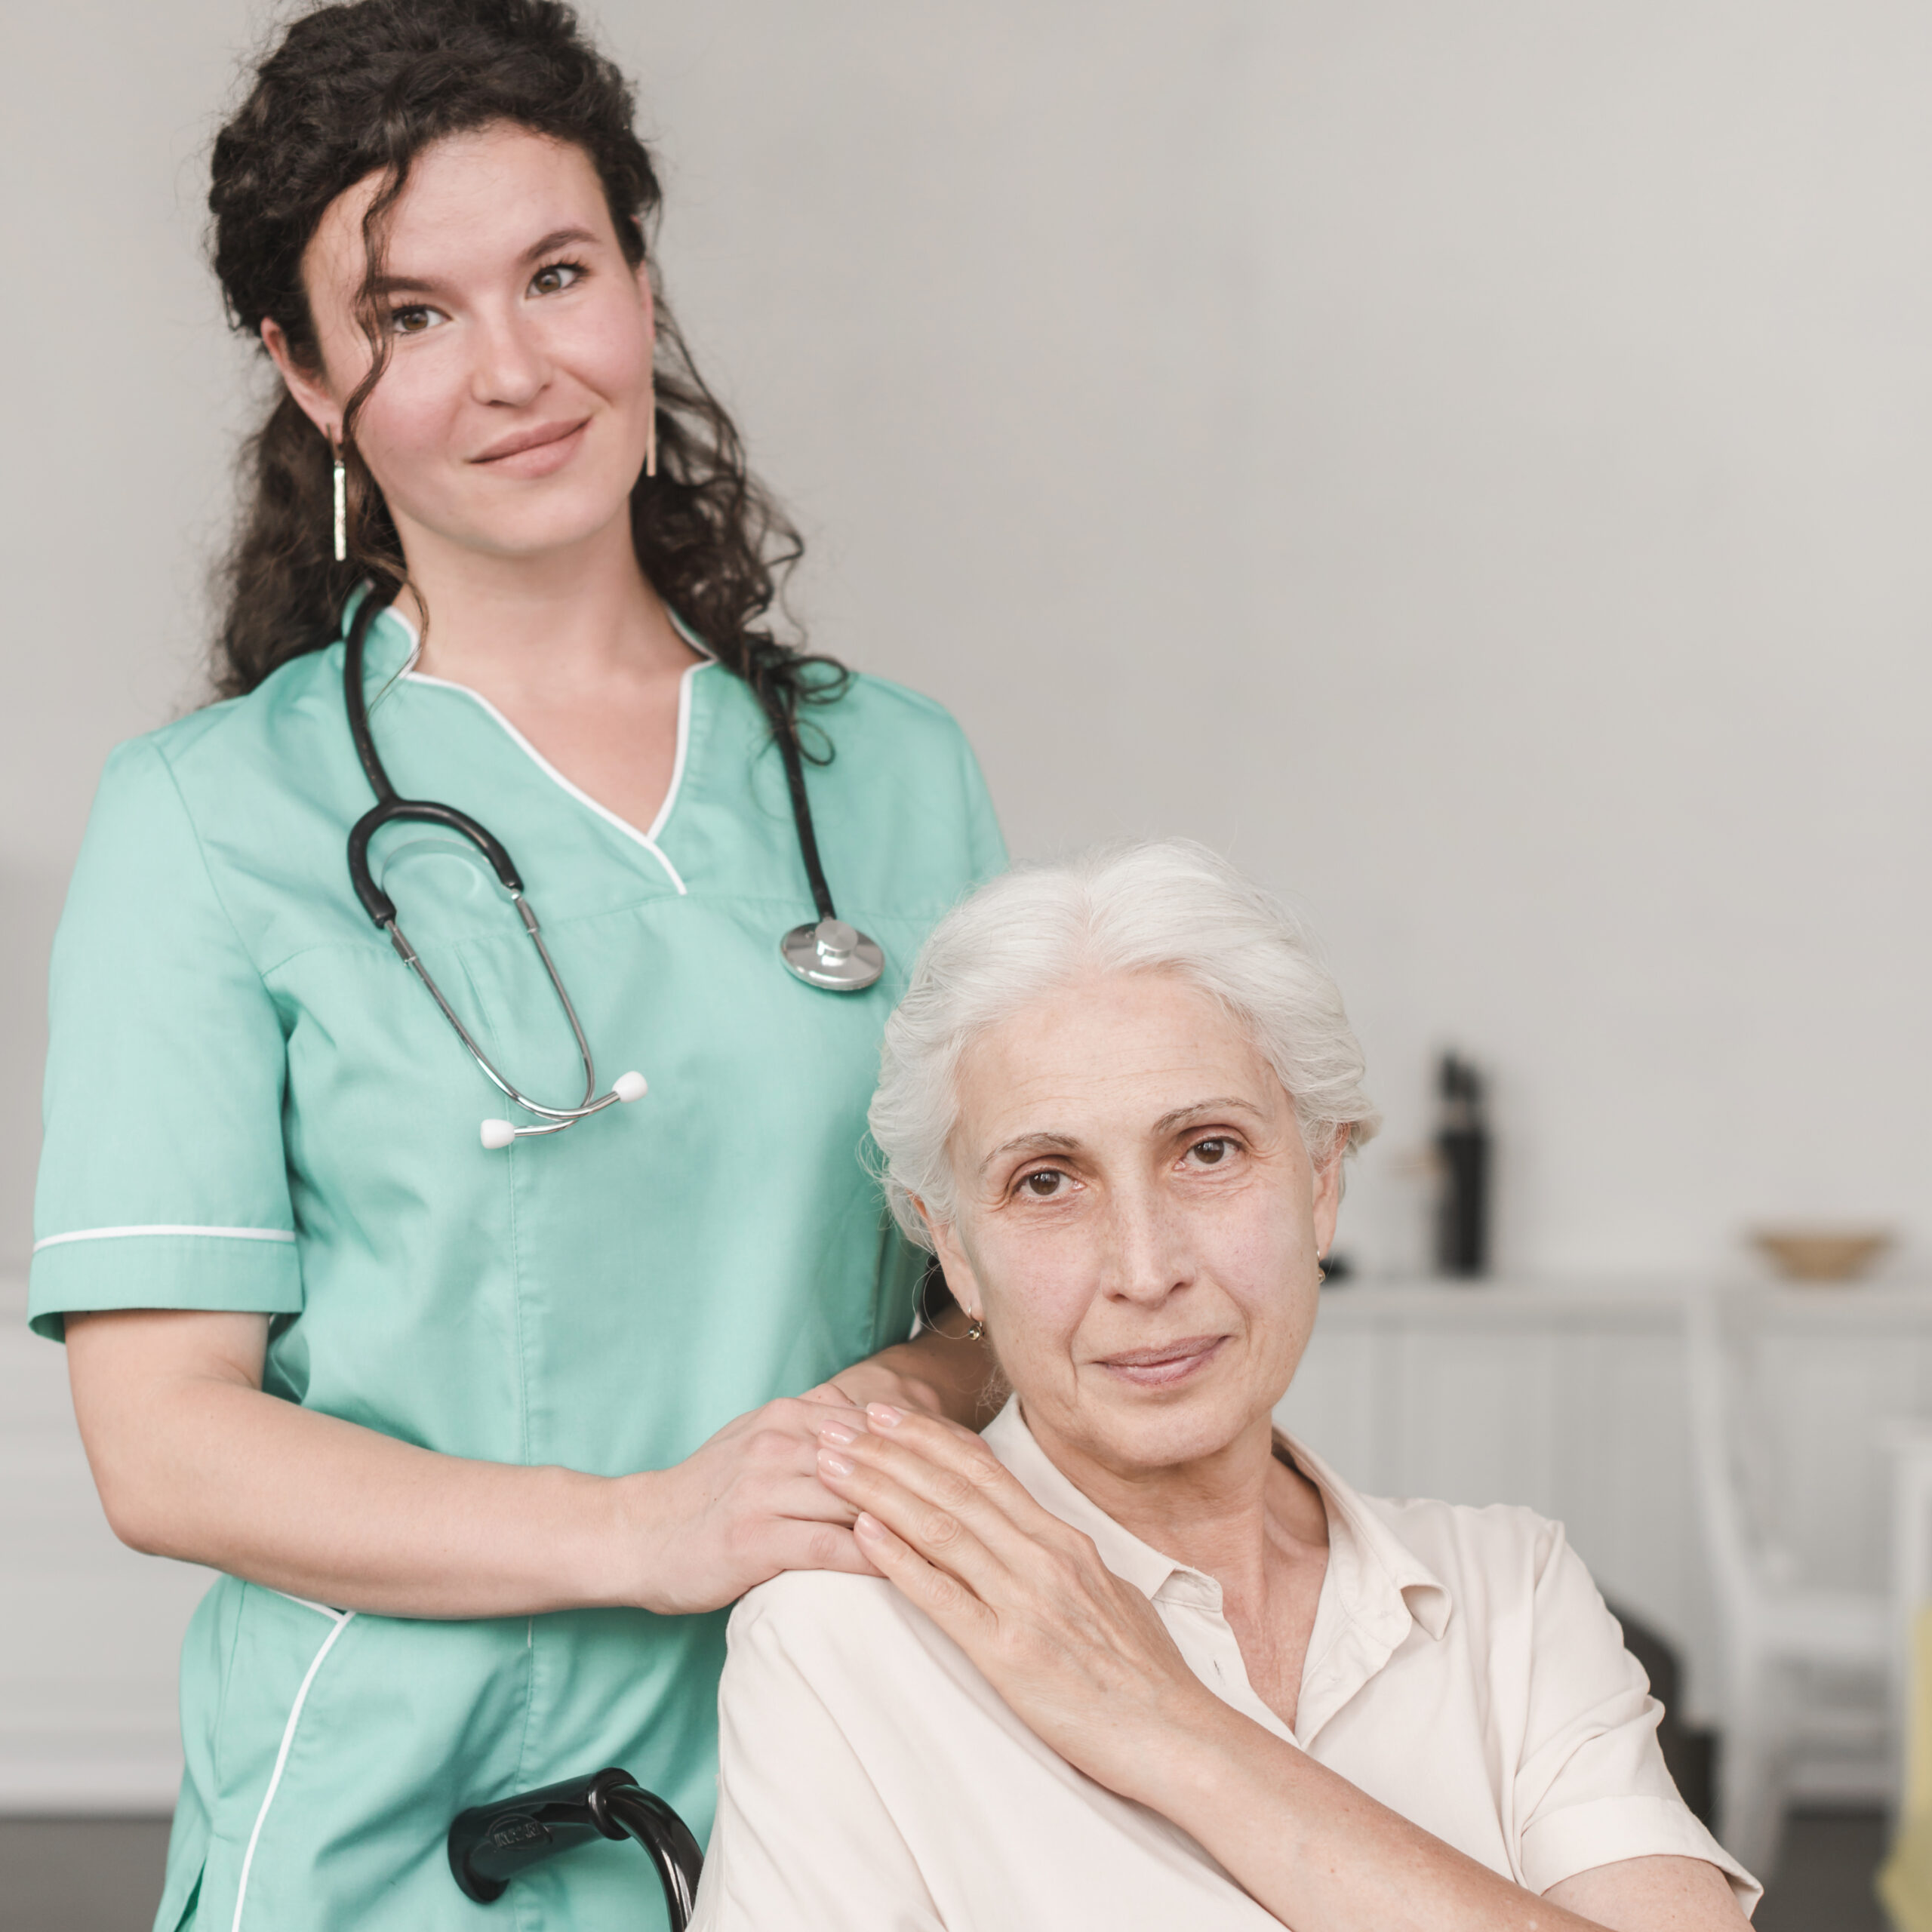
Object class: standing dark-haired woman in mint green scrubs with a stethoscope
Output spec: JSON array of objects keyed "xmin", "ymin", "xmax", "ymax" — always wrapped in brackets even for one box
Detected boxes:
[{"xmin": 31, "ymin": 0, "xmax": 1003, "ymax": 1932}]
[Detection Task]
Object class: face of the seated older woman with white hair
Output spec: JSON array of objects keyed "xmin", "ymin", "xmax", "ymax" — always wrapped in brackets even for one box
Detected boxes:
[{"xmin": 935, "ymin": 974, "xmax": 1341, "ymax": 1474}]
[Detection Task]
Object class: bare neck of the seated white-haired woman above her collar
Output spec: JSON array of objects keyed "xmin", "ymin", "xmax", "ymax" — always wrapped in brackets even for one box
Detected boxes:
[{"xmin": 1028, "ymin": 1414, "xmax": 1327, "ymax": 1614}]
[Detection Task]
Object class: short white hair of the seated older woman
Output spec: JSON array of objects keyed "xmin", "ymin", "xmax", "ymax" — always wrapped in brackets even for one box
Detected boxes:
[{"xmin": 869, "ymin": 838, "xmax": 1381, "ymax": 1248}]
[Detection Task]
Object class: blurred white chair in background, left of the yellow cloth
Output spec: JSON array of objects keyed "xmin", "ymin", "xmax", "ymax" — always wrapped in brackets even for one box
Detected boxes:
[{"xmin": 1684, "ymin": 1297, "xmax": 1894, "ymax": 1878}]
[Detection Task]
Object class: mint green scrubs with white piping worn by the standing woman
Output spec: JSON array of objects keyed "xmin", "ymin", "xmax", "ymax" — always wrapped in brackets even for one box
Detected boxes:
[{"xmin": 31, "ymin": 617, "xmax": 1004, "ymax": 1932}]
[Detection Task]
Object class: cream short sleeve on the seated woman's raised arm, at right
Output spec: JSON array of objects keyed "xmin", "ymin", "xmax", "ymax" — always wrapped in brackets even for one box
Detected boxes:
[{"xmin": 1515, "ymin": 1522, "xmax": 1764, "ymax": 1912}]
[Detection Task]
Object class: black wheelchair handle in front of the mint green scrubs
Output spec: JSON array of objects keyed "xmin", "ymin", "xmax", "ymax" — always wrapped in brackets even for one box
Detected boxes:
[{"xmin": 450, "ymin": 1766, "xmax": 705, "ymax": 1932}]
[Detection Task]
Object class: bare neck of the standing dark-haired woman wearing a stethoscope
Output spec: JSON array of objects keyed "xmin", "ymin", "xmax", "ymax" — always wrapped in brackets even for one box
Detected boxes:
[{"xmin": 396, "ymin": 514, "xmax": 694, "ymax": 703}]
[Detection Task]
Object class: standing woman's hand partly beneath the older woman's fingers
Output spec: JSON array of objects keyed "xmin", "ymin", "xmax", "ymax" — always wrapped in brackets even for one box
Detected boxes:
[{"xmin": 618, "ymin": 1383, "xmax": 877, "ymax": 1617}]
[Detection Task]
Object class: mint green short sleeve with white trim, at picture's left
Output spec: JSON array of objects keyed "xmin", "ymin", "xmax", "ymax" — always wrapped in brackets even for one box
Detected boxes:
[{"xmin": 27, "ymin": 738, "xmax": 301, "ymax": 1341}]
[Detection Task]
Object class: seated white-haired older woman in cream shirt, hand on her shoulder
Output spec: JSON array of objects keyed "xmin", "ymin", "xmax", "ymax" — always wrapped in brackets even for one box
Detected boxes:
[{"xmin": 696, "ymin": 844, "xmax": 1758, "ymax": 1932}]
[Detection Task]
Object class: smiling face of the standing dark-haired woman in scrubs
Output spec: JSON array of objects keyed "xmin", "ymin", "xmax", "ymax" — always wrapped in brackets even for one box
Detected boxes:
[{"xmin": 265, "ymin": 125, "xmax": 651, "ymax": 568}]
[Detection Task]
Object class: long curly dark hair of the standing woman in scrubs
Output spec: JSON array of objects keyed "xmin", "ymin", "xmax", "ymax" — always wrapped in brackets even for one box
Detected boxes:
[{"xmin": 208, "ymin": 0, "xmax": 844, "ymax": 721}]
